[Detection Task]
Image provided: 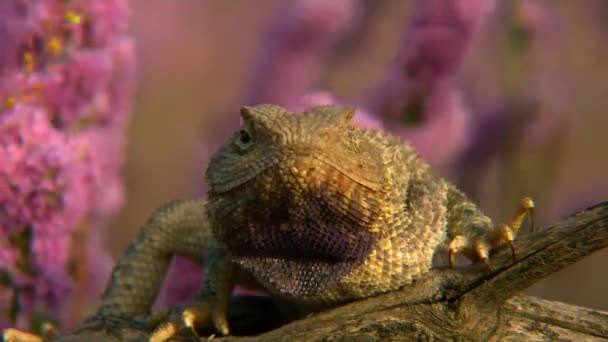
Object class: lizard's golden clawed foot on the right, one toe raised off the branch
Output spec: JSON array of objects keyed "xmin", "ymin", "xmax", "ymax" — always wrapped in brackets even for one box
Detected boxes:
[{"xmin": 448, "ymin": 197, "xmax": 534, "ymax": 272}]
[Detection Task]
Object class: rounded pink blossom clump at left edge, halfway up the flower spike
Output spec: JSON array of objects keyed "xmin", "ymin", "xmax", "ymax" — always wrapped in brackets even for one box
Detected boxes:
[{"xmin": 0, "ymin": 105, "xmax": 90, "ymax": 234}]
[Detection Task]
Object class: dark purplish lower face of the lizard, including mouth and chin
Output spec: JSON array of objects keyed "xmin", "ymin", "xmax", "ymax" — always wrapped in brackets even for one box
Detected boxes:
[{"xmin": 213, "ymin": 197, "xmax": 378, "ymax": 298}]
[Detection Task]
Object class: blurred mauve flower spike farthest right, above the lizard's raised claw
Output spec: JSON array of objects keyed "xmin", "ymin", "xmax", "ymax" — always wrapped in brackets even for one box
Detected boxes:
[{"xmin": 455, "ymin": 0, "xmax": 576, "ymax": 198}]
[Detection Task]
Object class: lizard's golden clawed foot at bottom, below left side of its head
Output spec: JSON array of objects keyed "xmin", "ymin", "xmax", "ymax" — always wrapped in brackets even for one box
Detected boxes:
[{"xmin": 149, "ymin": 299, "xmax": 230, "ymax": 342}]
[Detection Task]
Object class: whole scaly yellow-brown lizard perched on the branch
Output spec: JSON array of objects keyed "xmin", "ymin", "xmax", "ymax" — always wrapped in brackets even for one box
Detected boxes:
[{"xmin": 1, "ymin": 104, "xmax": 534, "ymax": 342}]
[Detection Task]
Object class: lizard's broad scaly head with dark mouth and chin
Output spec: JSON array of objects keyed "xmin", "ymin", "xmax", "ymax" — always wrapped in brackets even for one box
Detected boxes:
[{"xmin": 206, "ymin": 105, "xmax": 388, "ymax": 298}]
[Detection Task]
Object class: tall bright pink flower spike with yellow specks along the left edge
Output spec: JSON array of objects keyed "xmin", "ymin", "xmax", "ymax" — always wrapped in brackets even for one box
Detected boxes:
[{"xmin": 0, "ymin": 0, "xmax": 135, "ymax": 328}]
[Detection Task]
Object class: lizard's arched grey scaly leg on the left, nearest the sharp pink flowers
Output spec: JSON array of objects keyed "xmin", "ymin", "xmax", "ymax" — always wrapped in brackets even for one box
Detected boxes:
[{"xmin": 65, "ymin": 200, "xmax": 211, "ymax": 340}]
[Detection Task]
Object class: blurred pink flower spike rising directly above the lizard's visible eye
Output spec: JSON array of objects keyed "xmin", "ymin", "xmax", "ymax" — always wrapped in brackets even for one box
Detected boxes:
[{"xmin": 245, "ymin": 0, "xmax": 361, "ymax": 105}]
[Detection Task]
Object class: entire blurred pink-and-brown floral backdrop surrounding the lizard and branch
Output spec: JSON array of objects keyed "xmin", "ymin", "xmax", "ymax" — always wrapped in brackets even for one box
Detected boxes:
[{"xmin": 5, "ymin": 0, "xmax": 608, "ymax": 331}]
